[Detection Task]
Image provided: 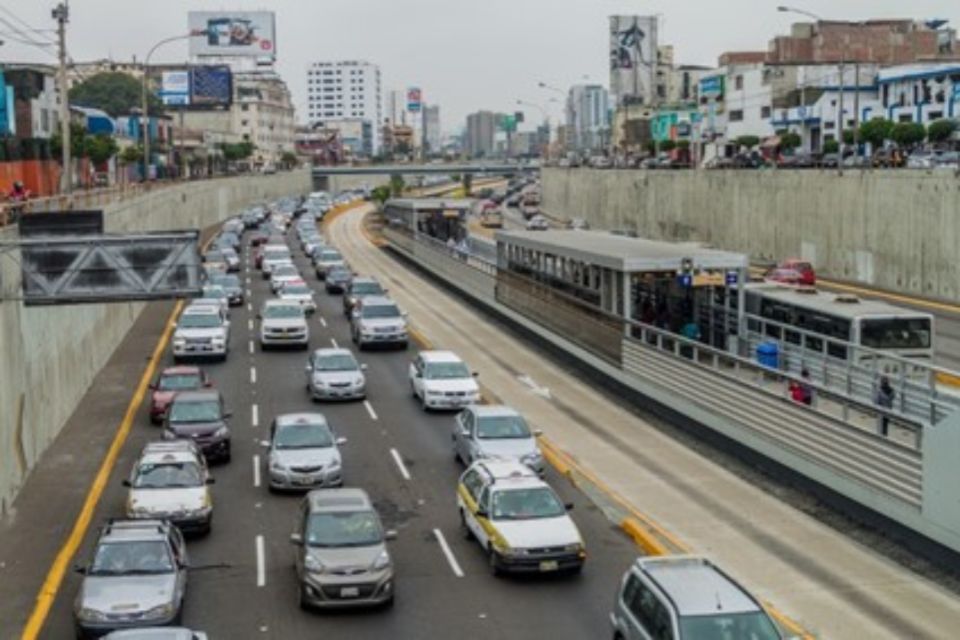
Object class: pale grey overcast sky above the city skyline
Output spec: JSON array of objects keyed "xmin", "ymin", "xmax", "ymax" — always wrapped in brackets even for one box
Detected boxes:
[{"xmin": 0, "ymin": 0, "xmax": 960, "ymax": 132}]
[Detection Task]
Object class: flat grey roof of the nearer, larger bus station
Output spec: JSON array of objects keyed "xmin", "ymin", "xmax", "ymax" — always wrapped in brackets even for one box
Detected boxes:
[{"xmin": 496, "ymin": 230, "xmax": 749, "ymax": 273}]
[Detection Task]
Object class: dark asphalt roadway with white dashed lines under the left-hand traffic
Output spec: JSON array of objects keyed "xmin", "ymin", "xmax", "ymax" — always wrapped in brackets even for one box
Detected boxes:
[{"xmin": 31, "ymin": 208, "xmax": 636, "ymax": 639}]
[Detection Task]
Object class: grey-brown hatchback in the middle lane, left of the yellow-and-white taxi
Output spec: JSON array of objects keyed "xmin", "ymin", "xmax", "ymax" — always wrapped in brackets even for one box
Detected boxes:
[{"xmin": 290, "ymin": 489, "xmax": 396, "ymax": 609}]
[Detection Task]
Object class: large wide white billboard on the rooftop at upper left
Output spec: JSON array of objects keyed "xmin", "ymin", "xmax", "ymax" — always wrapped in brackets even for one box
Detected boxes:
[{"xmin": 187, "ymin": 11, "xmax": 277, "ymax": 61}]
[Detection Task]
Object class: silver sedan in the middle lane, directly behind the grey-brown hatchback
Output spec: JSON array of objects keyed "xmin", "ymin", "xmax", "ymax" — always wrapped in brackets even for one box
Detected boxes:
[{"xmin": 261, "ymin": 413, "xmax": 347, "ymax": 491}]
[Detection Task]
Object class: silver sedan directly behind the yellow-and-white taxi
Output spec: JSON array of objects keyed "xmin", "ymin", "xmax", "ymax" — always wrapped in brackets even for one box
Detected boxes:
[{"xmin": 452, "ymin": 404, "xmax": 544, "ymax": 475}]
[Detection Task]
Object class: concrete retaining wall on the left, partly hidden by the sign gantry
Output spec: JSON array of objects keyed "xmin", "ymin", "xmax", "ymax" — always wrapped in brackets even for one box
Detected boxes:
[{"xmin": 0, "ymin": 171, "xmax": 310, "ymax": 515}]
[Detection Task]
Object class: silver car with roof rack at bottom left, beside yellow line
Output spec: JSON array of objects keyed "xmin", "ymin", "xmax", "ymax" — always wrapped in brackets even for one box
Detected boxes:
[{"xmin": 73, "ymin": 520, "xmax": 189, "ymax": 638}]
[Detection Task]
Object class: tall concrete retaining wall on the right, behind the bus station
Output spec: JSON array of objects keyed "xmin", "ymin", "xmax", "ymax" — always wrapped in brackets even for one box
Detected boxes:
[{"xmin": 543, "ymin": 169, "xmax": 960, "ymax": 301}]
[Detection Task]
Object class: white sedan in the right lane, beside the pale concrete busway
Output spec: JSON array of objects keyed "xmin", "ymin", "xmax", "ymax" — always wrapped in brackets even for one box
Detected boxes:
[{"xmin": 410, "ymin": 351, "xmax": 480, "ymax": 411}]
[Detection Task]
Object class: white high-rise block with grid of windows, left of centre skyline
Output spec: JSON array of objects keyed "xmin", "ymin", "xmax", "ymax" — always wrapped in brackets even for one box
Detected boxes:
[{"xmin": 307, "ymin": 60, "xmax": 383, "ymax": 153}]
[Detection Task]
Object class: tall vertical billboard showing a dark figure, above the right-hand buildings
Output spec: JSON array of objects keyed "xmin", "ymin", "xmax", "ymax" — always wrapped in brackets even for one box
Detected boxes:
[{"xmin": 610, "ymin": 16, "xmax": 657, "ymax": 107}]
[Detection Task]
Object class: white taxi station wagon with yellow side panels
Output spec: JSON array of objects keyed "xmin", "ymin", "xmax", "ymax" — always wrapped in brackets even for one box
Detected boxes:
[{"xmin": 457, "ymin": 459, "xmax": 587, "ymax": 575}]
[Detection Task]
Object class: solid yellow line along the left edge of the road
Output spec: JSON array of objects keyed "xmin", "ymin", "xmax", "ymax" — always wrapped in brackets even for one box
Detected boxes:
[{"xmin": 20, "ymin": 301, "xmax": 183, "ymax": 640}]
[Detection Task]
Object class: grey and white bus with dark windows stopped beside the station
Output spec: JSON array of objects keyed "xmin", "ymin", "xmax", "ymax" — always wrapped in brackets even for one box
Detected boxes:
[{"xmin": 746, "ymin": 283, "xmax": 934, "ymax": 374}]
